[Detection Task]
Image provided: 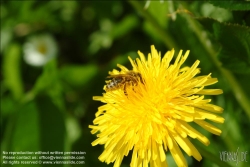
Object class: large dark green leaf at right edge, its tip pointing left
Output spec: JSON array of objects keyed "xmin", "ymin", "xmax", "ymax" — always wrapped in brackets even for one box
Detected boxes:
[{"xmin": 198, "ymin": 18, "xmax": 250, "ymax": 74}]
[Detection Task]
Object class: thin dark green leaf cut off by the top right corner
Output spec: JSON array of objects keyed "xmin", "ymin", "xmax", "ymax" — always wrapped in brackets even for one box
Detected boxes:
[{"xmin": 209, "ymin": 0, "xmax": 250, "ymax": 10}]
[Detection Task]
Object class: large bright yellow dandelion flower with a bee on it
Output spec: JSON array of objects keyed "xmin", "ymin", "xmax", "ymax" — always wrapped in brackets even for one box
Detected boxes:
[{"xmin": 89, "ymin": 46, "xmax": 224, "ymax": 167}]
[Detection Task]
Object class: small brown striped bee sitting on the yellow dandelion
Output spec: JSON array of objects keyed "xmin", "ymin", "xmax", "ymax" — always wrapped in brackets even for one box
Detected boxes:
[{"xmin": 106, "ymin": 71, "xmax": 143, "ymax": 95}]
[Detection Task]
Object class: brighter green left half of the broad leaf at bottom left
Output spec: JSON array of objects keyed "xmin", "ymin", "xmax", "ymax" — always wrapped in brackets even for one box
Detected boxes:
[{"xmin": 1, "ymin": 102, "xmax": 40, "ymax": 167}]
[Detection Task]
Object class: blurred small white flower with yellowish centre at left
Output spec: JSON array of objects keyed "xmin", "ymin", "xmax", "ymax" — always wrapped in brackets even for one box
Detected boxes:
[{"xmin": 23, "ymin": 34, "xmax": 57, "ymax": 66}]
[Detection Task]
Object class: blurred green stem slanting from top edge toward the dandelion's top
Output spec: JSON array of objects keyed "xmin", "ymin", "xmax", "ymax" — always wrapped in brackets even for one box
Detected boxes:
[{"xmin": 129, "ymin": 0, "xmax": 180, "ymax": 50}]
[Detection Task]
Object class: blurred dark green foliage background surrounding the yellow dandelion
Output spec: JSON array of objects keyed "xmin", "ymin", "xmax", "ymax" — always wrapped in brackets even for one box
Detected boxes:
[{"xmin": 0, "ymin": 0, "xmax": 250, "ymax": 167}]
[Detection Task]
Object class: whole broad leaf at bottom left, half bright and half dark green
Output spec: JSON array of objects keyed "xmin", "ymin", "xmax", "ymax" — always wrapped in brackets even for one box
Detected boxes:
[{"xmin": 1, "ymin": 96, "xmax": 66, "ymax": 167}]
